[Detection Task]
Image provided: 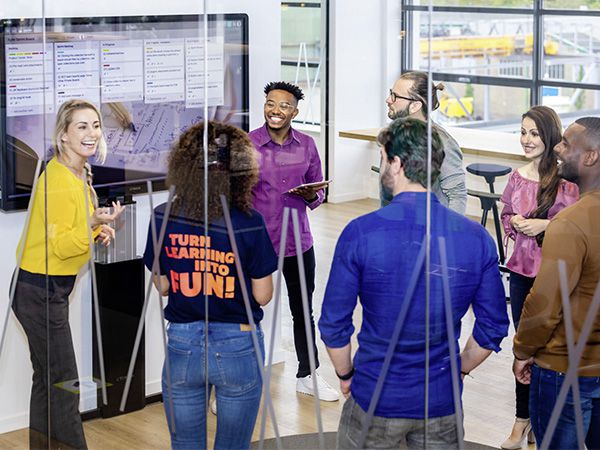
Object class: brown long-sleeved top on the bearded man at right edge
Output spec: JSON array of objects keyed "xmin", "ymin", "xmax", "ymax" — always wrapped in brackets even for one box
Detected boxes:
[{"xmin": 513, "ymin": 190, "xmax": 600, "ymax": 376}]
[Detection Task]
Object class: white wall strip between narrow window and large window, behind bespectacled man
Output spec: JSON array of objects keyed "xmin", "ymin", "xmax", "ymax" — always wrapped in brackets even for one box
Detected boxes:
[{"xmin": 329, "ymin": 0, "xmax": 400, "ymax": 203}]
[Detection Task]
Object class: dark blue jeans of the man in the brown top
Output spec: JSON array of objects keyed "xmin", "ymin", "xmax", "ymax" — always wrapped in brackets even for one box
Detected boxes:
[{"xmin": 529, "ymin": 364, "xmax": 600, "ymax": 450}]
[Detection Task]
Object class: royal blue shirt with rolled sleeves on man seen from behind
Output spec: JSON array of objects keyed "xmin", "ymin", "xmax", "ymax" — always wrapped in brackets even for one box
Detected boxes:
[{"xmin": 319, "ymin": 192, "xmax": 508, "ymax": 419}]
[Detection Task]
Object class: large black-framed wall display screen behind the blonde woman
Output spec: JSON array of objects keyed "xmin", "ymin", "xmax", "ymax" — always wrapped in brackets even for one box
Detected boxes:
[{"xmin": 0, "ymin": 14, "xmax": 249, "ymax": 210}]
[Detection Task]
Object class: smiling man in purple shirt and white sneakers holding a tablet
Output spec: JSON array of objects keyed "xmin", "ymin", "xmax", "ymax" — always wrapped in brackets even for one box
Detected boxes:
[{"xmin": 249, "ymin": 81, "xmax": 339, "ymax": 401}]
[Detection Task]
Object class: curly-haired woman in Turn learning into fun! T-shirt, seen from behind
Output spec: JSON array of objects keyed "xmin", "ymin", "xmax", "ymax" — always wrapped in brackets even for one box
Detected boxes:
[{"xmin": 144, "ymin": 122, "xmax": 277, "ymax": 449}]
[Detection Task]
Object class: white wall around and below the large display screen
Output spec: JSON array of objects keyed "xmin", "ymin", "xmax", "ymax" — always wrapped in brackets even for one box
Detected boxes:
[{"xmin": 0, "ymin": 0, "xmax": 281, "ymax": 433}]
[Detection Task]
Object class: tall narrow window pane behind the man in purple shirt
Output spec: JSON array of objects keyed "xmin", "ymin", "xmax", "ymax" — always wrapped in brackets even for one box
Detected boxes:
[{"xmin": 281, "ymin": 1, "xmax": 323, "ymax": 125}]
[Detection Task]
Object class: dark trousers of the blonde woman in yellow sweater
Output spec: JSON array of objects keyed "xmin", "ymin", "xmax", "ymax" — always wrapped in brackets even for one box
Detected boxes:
[{"xmin": 12, "ymin": 269, "xmax": 87, "ymax": 449}]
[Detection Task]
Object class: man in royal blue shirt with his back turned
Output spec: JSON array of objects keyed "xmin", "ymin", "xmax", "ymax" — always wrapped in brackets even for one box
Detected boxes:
[{"xmin": 319, "ymin": 118, "xmax": 508, "ymax": 449}]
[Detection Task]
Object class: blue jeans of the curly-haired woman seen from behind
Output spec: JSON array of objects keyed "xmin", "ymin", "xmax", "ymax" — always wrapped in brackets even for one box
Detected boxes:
[{"xmin": 162, "ymin": 321, "xmax": 264, "ymax": 449}]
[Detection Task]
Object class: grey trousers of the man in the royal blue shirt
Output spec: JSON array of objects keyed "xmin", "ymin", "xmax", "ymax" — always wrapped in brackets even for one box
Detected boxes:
[{"xmin": 337, "ymin": 397, "xmax": 462, "ymax": 450}]
